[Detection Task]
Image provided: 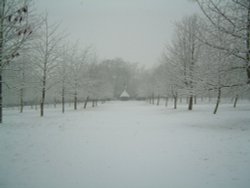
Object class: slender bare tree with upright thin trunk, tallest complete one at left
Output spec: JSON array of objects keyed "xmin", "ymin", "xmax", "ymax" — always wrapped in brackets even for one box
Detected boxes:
[{"xmin": 33, "ymin": 14, "xmax": 64, "ymax": 116}]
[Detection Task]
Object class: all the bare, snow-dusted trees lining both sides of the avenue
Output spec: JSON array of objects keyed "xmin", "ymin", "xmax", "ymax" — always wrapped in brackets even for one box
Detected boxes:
[{"xmin": 0, "ymin": 0, "xmax": 250, "ymax": 123}]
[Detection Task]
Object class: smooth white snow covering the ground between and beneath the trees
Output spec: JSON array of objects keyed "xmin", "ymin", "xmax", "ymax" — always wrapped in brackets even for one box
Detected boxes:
[{"xmin": 0, "ymin": 102, "xmax": 250, "ymax": 188}]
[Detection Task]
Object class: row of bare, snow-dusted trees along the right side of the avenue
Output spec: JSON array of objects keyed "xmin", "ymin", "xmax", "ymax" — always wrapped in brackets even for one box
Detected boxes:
[{"xmin": 144, "ymin": 0, "xmax": 250, "ymax": 114}]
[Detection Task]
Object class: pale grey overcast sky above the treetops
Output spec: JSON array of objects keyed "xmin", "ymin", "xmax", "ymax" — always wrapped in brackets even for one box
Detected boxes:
[{"xmin": 35, "ymin": 0, "xmax": 199, "ymax": 66}]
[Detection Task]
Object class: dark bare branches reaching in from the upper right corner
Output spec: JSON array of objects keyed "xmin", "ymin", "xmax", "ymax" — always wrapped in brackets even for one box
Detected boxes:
[{"xmin": 195, "ymin": 0, "xmax": 250, "ymax": 84}]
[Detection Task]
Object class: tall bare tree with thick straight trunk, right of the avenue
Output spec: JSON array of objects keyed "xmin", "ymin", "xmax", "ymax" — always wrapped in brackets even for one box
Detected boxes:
[{"xmin": 176, "ymin": 15, "xmax": 200, "ymax": 110}]
